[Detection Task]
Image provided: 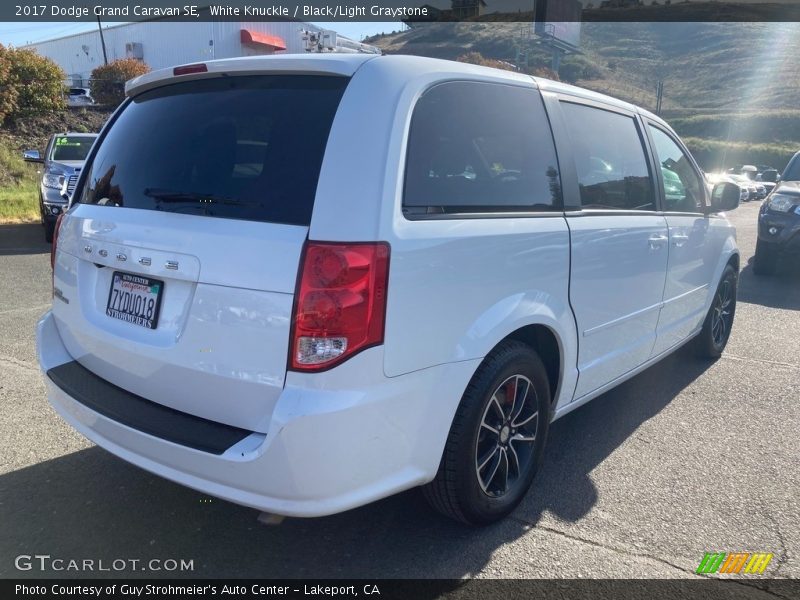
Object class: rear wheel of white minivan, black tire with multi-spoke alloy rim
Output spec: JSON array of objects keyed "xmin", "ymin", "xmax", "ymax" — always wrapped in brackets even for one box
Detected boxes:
[{"xmin": 423, "ymin": 341, "xmax": 550, "ymax": 525}]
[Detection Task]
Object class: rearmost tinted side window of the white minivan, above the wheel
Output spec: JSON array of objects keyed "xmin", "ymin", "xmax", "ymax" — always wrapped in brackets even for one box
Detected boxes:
[{"xmin": 403, "ymin": 82, "xmax": 561, "ymax": 213}]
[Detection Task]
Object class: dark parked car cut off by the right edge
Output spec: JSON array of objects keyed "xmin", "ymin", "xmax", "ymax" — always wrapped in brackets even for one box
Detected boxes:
[{"xmin": 753, "ymin": 152, "xmax": 800, "ymax": 275}]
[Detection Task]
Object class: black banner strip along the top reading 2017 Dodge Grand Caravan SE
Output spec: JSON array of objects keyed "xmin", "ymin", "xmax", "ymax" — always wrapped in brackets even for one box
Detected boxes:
[{"xmin": 0, "ymin": 0, "xmax": 800, "ymax": 24}]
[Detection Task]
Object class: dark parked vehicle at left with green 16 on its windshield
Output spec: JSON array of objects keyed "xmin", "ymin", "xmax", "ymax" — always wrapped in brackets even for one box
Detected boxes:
[{"xmin": 23, "ymin": 133, "xmax": 97, "ymax": 242}]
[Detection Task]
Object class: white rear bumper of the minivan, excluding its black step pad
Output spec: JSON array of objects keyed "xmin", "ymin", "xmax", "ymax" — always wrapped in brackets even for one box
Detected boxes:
[{"xmin": 37, "ymin": 313, "xmax": 479, "ymax": 517}]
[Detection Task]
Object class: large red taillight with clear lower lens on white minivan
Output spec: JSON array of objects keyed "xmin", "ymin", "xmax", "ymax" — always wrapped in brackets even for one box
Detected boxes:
[{"xmin": 290, "ymin": 242, "xmax": 389, "ymax": 371}]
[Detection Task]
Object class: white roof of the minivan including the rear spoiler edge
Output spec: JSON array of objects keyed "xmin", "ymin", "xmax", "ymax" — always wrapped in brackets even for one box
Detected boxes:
[{"xmin": 125, "ymin": 53, "xmax": 664, "ymax": 123}]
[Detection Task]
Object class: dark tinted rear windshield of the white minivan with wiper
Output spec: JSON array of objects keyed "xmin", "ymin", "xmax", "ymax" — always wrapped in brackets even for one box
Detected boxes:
[{"xmin": 81, "ymin": 75, "xmax": 348, "ymax": 225}]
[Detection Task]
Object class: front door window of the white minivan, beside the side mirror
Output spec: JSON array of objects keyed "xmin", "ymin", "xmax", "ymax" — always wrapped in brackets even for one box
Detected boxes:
[{"xmin": 650, "ymin": 125, "xmax": 705, "ymax": 212}]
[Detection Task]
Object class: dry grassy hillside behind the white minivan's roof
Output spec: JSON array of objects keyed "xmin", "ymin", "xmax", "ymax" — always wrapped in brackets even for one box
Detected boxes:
[{"xmin": 369, "ymin": 23, "xmax": 800, "ymax": 169}]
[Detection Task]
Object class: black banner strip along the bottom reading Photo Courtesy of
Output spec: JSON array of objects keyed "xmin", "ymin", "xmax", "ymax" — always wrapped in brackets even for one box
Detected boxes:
[{"xmin": 0, "ymin": 576, "xmax": 800, "ymax": 600}]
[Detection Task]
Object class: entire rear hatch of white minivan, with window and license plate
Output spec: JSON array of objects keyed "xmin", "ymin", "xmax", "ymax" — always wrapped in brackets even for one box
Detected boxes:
[{"xmin": 53, "ymin": 74, "xmax": 348, "ymax": 432}]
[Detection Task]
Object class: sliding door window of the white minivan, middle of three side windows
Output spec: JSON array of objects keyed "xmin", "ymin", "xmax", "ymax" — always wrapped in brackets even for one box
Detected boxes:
[{"xmin": 561, "ymin": 102, "xmax": 655, "ymax": 210}]
